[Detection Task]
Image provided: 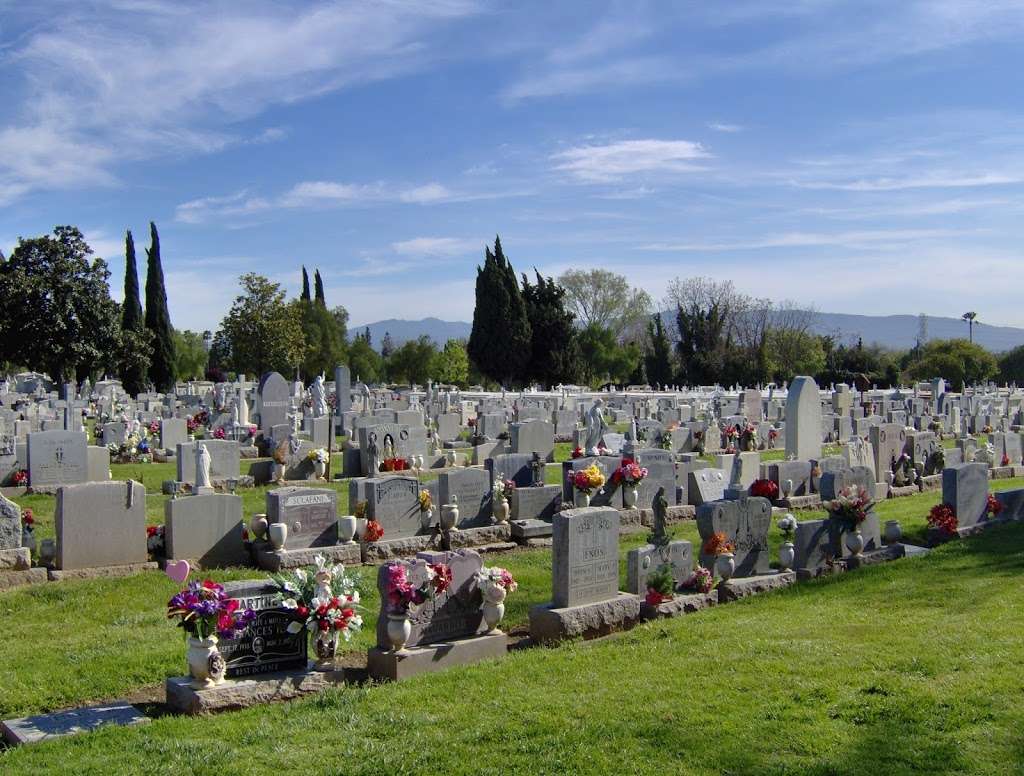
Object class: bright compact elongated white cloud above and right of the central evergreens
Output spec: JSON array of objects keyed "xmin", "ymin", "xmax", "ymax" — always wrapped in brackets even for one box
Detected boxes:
[{"xmin": 552, "ymin": 139, "xmax": 711, "ymax": 182}]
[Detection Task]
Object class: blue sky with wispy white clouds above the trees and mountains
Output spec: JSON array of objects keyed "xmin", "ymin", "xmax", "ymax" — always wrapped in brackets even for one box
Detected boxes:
[{"xmin": 0, "ymin": 0, "xmax": 1024, "ymax": 330}]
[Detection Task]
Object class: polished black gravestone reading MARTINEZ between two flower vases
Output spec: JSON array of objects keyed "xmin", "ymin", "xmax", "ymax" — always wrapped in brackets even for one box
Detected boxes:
[{"xmin": 220, "ymin": 581, "xmax": 308, "ymax": 679}]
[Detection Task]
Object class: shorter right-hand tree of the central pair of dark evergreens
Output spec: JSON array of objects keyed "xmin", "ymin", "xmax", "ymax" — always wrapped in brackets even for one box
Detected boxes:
[{"xmin": 522, "ymin": 269, "xmax": 580, "ymax": 387}]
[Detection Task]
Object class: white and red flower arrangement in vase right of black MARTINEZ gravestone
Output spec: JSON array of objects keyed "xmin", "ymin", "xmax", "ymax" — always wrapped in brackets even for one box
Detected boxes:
[{"xmin": 270, "ymin": 555, "xmax": 362, "ymax": 658}]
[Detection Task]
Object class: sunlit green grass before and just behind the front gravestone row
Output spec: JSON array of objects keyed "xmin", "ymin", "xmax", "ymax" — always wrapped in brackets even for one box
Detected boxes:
[{"xmin": 0, "ymin": 522, "xmax": 1024, "ymax": 776}]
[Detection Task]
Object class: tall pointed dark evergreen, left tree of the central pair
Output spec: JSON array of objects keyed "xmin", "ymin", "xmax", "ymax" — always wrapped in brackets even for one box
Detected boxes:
[{"xmin": 467, "ymin": 236, "xmax": 532, "ymax": 385}]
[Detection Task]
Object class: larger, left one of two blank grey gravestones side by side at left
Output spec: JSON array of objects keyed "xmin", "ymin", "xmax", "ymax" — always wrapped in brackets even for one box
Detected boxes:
[{"xmin": 54, "ymin": 481, "xmax": 148, "ymax": 570}]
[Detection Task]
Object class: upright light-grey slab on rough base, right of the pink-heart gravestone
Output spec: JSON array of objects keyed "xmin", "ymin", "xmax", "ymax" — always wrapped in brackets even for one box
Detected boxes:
[{"xmin": 552, "ymin": 507, "xmax": 620, "ymax": 609}]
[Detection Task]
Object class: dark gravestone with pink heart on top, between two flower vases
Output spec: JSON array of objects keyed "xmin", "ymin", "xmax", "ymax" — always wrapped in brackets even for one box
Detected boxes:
[{"xmin": 377, "ymin": 550, "xmax": 486, "ymax": 649}]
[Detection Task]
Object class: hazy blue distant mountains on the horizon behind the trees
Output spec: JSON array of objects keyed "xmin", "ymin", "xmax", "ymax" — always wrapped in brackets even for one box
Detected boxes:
[{"xmin": 350, "ymin": 312, "xmax": 1024, "ymax": 352}]
